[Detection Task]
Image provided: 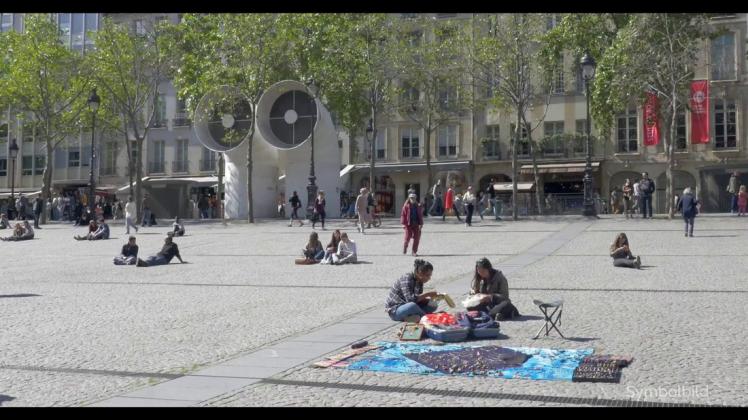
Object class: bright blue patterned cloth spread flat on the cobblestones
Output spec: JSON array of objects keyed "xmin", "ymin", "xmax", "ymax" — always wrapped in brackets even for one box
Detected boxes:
[{"xmin": 345, "ymin": 341, "xmax": 594, "ymax": 381}]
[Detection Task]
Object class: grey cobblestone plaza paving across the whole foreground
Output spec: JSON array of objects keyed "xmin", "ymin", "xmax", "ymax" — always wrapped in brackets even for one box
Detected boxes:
[{"xmin": 0, "ymin": 215, "xmax": 748, "ymax": 407}]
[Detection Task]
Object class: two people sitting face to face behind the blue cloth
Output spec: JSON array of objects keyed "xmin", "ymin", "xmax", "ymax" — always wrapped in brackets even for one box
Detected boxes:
[{"xmin": 385, "ymin": 258, "xmax": 520, "ymax": 322}]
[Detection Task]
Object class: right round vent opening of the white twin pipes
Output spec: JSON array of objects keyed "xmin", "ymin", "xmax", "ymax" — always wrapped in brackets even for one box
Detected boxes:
[{"xmin": 257, "ymin": 80, "xmax": 317, "ymax": 149}]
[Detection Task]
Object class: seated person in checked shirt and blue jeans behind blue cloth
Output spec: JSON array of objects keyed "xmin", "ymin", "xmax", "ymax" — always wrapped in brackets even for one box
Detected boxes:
[{"xmin": 385, "ymin": 259, "xmax": 438, "ymax": 322}]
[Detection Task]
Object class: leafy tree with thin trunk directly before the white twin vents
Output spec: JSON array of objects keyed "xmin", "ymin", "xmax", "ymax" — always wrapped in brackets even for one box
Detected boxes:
[{"xmin": 168, "ymin": 13, "xmax": 290, "ymax": 223}]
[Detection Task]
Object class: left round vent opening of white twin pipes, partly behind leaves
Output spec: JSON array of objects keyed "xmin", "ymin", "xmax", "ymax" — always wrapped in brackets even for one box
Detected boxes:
[{"xmin": 195, "ymin": 86, "xmax": 252, "ymax": 152}]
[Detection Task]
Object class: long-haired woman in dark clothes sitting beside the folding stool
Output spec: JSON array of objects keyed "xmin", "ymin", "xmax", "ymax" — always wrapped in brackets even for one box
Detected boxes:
[{"xmin": 467, "ymin": 258, "xmax": 519, "ymax": 321}]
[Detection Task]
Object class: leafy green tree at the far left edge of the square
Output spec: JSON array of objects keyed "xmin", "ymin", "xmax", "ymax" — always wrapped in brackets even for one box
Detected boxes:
[{"xmin": 0, "ymin": 14, "xmax": 90, "ymax": 223}]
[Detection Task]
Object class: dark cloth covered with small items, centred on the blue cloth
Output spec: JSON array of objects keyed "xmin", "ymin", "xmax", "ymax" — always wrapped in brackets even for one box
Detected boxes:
[{"xmin": 404, "ymin": 346, "xmax": 530, "ymax": 375}]
